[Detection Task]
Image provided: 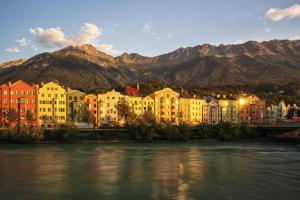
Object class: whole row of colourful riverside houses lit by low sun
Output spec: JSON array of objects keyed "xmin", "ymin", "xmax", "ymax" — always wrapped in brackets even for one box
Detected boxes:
[{"xmin": 0, "ymin": 80, "xmax": 296, "ymax": 127}]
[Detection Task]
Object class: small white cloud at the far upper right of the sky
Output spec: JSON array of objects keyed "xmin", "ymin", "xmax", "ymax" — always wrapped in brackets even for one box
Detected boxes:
[{"xmin": 265, "ymin": 4, "xmax": 300, "ymax": 21}]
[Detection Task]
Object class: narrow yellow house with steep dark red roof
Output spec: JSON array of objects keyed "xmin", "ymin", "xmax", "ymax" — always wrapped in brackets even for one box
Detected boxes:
[{"xmin": 125, "ymin": 86, "xmax": 144, "ymax": 117}]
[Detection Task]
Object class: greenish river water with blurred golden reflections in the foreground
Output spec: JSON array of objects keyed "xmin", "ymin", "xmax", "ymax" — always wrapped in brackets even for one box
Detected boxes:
[{"xmin": 0, "ymin": 143, "xmax": 300, "ymax": 200}]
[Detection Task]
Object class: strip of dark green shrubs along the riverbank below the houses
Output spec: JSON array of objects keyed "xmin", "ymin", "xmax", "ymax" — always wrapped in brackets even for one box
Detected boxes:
[{"xmin": 0, "ymin": 123, "xmax": 296, "ymax": 143}]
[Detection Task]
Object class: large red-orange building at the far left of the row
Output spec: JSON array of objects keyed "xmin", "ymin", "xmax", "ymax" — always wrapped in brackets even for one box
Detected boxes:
[{"xmin": 0, "ymin": 80, "xmax": 38, "ymax": 126}]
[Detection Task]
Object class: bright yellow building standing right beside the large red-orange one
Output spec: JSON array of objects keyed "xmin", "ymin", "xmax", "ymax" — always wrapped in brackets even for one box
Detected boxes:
[{"xmin": 38, "ymin": 82, "xmax": 67, "ymax": 127}]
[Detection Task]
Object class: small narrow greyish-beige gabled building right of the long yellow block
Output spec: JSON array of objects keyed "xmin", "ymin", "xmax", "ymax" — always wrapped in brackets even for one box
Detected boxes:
[{"xmin": 202, "ymin": 97, "xmax": 219, "ymax": 124}]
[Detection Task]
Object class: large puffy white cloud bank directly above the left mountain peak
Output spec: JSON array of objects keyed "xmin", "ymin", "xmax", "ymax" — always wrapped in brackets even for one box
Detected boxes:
[{"xmin": 30, "ymin": 23, "xmax": 121, "ymax": 56}]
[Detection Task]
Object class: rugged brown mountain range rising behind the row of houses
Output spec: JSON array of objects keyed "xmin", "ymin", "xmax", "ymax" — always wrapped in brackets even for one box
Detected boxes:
[{"xmin": 0, "ymin": 40, "xmax": 300, "ymax": 89}]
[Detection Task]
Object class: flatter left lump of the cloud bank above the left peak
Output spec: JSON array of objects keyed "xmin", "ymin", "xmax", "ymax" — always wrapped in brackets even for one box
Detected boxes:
[{"xmin": 29, "ymin": 27, "xmax": 68, "ymax": 48}]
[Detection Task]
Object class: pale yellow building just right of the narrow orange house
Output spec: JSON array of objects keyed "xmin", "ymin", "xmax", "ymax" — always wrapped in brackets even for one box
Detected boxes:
[{"xmin": 98, "ymin": 89, "xmax": 125, "ymax": 125}]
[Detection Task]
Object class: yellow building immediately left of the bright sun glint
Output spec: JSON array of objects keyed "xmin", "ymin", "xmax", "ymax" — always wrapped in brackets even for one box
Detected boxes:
[{"xmin": 218, "ymin": 96, "xmax": 238, "ymax": 124}]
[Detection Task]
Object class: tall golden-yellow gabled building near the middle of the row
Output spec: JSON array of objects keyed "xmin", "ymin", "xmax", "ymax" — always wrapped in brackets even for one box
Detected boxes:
[{"xmin": 153, "ymin": 88, "xmax": 179, "ymax": 124}]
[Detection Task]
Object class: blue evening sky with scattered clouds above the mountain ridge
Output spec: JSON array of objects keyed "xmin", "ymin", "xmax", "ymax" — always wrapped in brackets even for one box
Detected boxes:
[{"xmin": 0, "ymin": 0, "xmax": 300, "ymax": 63}]
